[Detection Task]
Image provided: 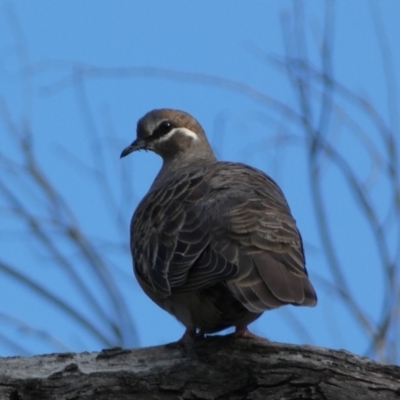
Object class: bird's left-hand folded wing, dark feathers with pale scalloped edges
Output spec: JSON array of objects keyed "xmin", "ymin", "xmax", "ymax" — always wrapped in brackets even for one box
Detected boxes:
[{"xmin": 131, "ymin": 171, "xmax": 237, "ymax": 297}]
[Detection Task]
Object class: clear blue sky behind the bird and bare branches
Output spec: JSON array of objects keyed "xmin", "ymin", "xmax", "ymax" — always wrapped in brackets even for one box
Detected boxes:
[{"xmin": 0, "ymin": 0, "xmax": 400, "ymax": 355}]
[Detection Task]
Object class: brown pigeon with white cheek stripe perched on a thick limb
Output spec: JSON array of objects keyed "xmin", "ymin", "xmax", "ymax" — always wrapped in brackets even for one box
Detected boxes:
[{"xmin": 121, "ymin": 109, "xmax": 317, "ymax": 341}]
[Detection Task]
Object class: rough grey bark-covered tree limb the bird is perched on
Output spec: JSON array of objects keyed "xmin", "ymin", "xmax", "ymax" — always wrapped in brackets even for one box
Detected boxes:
[{"xmin": 0, "ymin": 337, "xmax": 400, "ymax": 400}]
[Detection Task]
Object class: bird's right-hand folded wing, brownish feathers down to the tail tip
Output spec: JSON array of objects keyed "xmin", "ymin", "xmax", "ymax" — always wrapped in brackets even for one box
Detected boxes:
[{"xmin": 198, "ymin": 163, "xmax": 317, "ymax": 312}]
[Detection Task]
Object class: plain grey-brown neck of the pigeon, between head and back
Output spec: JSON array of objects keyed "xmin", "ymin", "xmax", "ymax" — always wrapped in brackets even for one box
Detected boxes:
[{"xmin": 150, "ymin": 152, "xmax": 218, "ymax": 190}]
